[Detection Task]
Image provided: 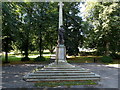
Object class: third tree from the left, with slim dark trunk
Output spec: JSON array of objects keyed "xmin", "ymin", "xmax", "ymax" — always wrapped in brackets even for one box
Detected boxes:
[{"xmin": 34, "ymin": 2, "xmax": 54, "ymax": 57}]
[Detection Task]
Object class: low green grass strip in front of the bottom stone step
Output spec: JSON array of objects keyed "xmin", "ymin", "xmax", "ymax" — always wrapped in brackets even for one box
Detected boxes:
[{"xmin": 35, "ymin": 80, "xmax": 97, "ymax": 87}]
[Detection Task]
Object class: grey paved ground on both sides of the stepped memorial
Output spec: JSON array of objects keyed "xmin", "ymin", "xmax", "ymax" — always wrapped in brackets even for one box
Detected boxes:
[{"xmin": 2, "ymin": 63, "xmax": 120, "ymax": 88}]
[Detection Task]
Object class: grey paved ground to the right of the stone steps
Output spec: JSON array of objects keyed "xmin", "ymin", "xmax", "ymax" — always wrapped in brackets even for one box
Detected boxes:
[{"xmin": 71, "ymin": 64, "xmax": 119, "ymax": 88}]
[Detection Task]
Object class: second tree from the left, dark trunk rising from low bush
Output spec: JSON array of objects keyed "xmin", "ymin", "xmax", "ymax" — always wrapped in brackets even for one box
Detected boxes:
[{"xmin": 15, "ymin": 2, "xmax": 34, "ymax": 61}]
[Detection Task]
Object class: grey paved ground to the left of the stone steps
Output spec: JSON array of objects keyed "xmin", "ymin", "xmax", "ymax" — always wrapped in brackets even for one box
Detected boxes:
[{"xmin": 2, "ymin": 64, "xmax": 44, "ymax": 88}]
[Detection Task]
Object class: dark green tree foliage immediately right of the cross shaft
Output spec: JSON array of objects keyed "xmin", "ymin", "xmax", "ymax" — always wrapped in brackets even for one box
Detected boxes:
[{"xmin": 64, "ymin": 3, "xmax": 83, "ymax": 56}]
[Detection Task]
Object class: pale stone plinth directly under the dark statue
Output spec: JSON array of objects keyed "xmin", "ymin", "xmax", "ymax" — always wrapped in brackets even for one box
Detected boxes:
[{"xmin": 56, "ymin": 45, "xmax": 67, "ymax": 62}]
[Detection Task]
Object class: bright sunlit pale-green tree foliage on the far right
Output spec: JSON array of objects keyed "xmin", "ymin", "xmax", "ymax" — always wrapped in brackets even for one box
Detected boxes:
[{"xmin": 85, "ymin": 2, "xmax": 120, "ymax": 56}]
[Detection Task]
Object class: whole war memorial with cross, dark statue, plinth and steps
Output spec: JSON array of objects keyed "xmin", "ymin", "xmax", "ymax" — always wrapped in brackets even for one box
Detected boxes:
[{"xmin": 24, "ymin": 2, "xmax": 100, "ymax": 82}]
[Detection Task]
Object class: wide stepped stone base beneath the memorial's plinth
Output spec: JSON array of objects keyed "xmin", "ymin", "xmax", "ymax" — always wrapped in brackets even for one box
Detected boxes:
[{"xmin": 24, "ymin": 61, "xmax": 100, "ymax": 82}]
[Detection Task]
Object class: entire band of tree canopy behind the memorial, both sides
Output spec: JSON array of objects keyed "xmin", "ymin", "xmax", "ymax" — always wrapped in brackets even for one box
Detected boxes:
[{"xmin": 2, "ymin": 2, "xmax": 120, "ymax": 62}]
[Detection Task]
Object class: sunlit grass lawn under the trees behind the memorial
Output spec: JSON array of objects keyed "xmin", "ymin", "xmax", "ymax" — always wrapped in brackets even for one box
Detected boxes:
[{"xmin": 2, "ymin": 52, "xmax": 119, "ymax": 64}]
